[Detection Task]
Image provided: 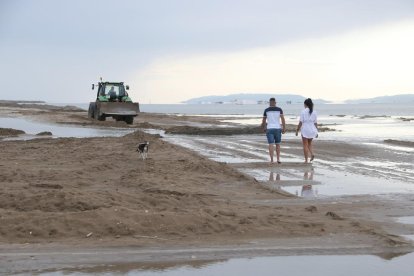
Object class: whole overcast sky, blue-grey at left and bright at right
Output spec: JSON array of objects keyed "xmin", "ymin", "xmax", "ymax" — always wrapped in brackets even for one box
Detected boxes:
[{"xmin": 0, "ymin": 0, "xmax": 414, "ymax": 103}]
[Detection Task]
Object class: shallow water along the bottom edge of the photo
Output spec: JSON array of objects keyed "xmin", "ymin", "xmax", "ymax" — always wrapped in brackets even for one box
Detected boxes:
[{"xmin": 30, "ymin": 253, "xmax": 414, "ymax": 276}]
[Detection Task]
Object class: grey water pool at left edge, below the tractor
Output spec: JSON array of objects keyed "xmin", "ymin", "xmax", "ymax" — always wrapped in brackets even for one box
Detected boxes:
[{"xmin": 0, "ymin": 118, "xmax": 134, "ymax": 140}]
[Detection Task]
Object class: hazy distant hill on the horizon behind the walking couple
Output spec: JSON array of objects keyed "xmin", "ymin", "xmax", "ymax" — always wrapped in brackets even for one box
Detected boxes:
[{"xmin": 182, "ymin": 93, "xmax": 328, "ymax": 104}]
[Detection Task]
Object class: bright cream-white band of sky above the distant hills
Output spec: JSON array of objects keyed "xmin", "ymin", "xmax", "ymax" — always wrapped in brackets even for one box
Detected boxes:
[{"xmin": 131, "ymin": 20, "xmax": 414, "ymax": 103}]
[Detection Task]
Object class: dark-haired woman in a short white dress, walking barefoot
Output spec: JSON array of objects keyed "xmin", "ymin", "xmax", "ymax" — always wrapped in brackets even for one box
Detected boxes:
[{"xmin": 296, "ymin": 98, "xmax": 318, "ymax": 163}]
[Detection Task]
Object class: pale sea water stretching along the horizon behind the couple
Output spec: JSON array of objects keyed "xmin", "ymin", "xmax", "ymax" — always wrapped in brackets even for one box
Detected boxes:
[{"xmin": 59, "ymin": 103, "xmax": 414, "ymax": 142}]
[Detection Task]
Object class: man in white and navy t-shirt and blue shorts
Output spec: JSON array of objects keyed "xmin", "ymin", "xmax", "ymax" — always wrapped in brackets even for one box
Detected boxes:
[{"xmin": 262, "ymin": 98, "xmax": 286, "ymax": 164}]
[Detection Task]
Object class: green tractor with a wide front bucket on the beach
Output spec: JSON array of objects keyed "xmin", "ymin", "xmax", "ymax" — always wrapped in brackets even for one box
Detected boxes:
[{"xmin": 88, "ymin": 81, "xmax": 139, "ymax": 124}]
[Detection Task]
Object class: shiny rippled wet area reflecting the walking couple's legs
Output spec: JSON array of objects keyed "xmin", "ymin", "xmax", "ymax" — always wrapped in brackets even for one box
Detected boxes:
[{"xmin": 165, "ymin": 135, "xmax": 414, "ymax": 198}]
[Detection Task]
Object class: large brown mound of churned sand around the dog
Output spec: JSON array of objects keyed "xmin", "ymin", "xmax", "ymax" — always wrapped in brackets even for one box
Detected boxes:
[{"xmin": 0, "ymin": 129, "xmax": 370, "ymax": 243}]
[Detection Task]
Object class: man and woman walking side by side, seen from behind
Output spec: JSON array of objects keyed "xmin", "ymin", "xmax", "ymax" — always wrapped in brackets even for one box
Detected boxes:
[{"xmin": 262, "ymin": 98, "xmax": 318, "ymax": 164}]
